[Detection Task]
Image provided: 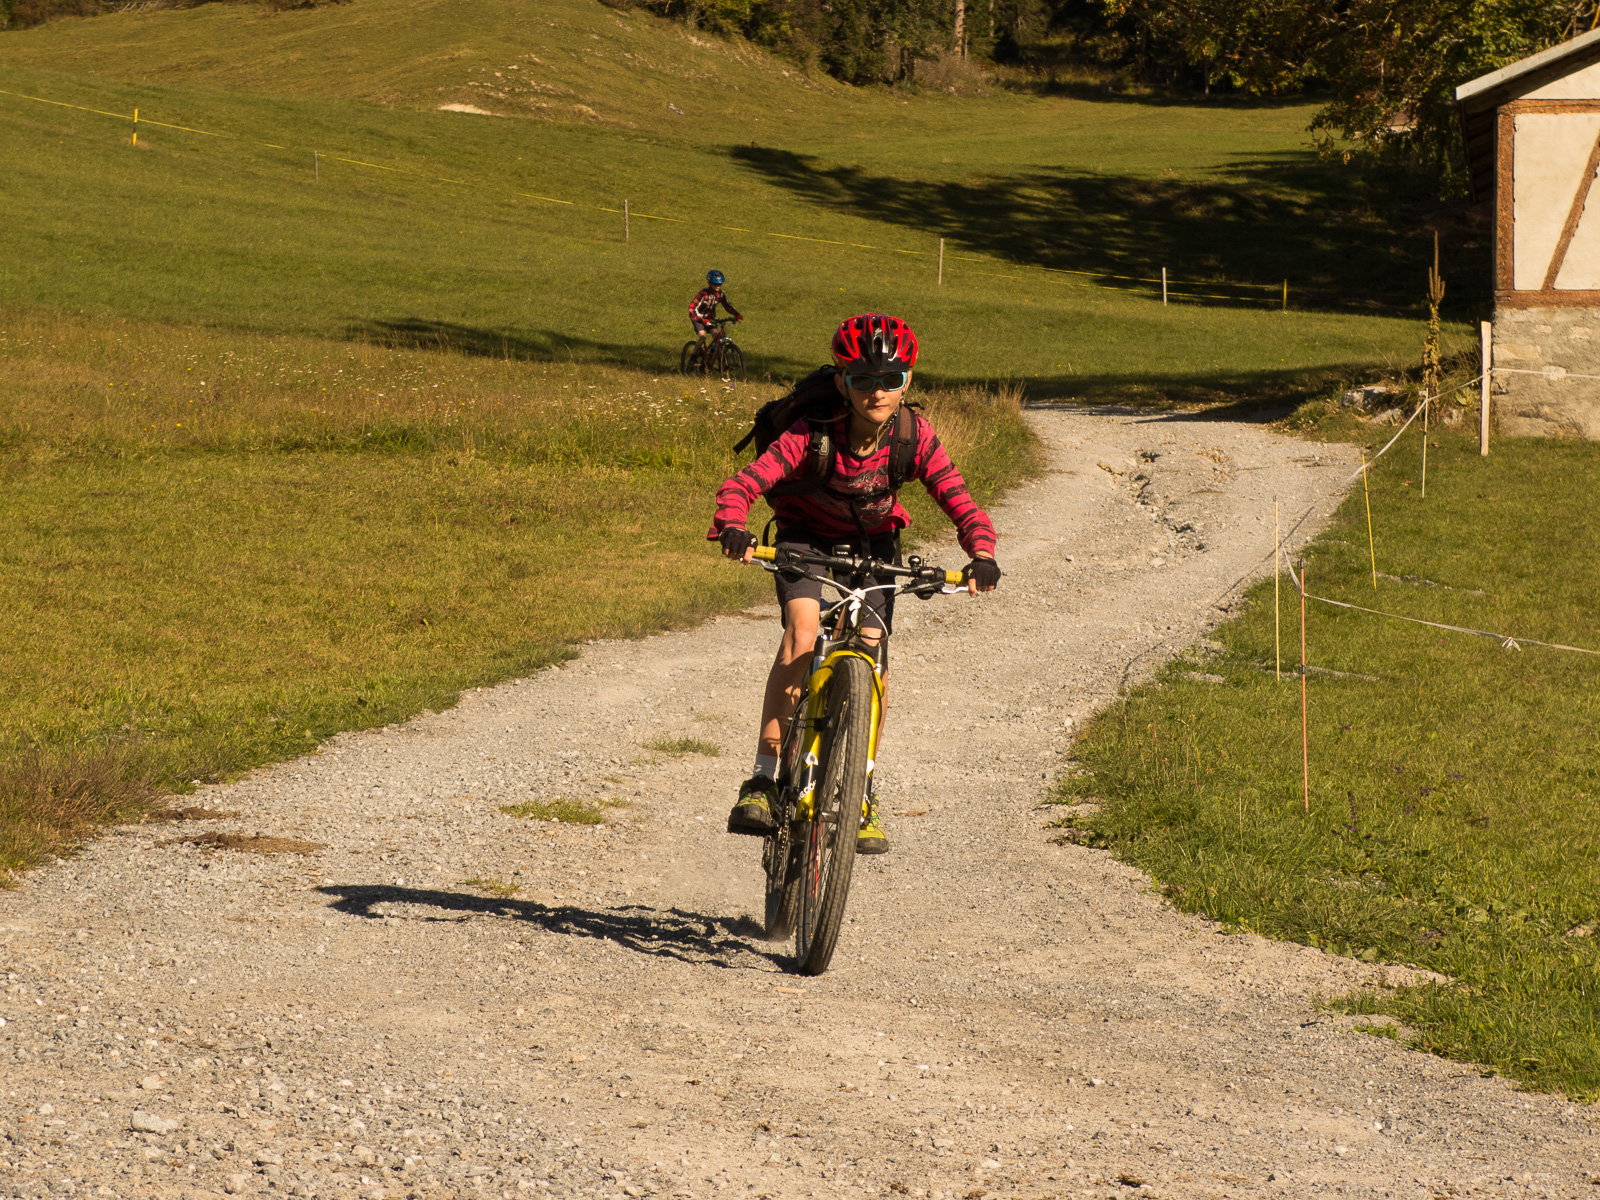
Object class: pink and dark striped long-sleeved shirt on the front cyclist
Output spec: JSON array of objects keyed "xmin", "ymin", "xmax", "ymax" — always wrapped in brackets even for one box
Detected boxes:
[{"xmin": 706, "ymin": 413, "xmax": 995, "ymax": 557}]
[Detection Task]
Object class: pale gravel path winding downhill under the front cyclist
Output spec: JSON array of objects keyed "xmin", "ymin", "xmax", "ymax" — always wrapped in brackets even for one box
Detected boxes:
[{"xmin": 0, "ymin": 410, "xmax": 1595, "ymax": 1200}]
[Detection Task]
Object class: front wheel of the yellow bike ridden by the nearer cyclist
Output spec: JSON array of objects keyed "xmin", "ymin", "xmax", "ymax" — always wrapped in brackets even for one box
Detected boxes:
[{"xmin": 795, "ymin": 654, "xmax": 872, "ymax": 974}]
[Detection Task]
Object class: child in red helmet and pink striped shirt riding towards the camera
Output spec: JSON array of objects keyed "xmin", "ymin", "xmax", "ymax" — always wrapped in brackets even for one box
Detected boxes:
[{"xmin": 707, "ymin": 312, "xmax": 1000, "ymax": 854}]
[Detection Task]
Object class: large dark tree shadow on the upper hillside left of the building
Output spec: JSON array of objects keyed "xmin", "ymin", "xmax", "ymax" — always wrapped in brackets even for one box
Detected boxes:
[{"xmin": 728, "ymin": 146, "xmax": 1490, "ymax": 312}]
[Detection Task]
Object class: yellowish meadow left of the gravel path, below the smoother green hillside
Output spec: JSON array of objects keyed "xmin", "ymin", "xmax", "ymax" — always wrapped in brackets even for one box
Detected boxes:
[{"xmin": 0, "ymin": 310, "xmax": 1034, "ymax": 869}]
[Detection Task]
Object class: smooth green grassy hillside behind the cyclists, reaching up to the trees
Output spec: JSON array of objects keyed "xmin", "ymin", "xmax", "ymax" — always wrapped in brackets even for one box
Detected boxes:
[{"xmin": 0, "ymin": 0, "xmax": 1462, "ymax": 397}]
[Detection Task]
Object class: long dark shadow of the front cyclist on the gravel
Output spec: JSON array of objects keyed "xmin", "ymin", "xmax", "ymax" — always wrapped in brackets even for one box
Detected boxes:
[{"xmin": 317, "ymin": 885, "xmax": 789, "ymax": 971}]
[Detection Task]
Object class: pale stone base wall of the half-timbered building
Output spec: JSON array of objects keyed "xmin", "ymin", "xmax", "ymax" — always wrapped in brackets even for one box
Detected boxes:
[{"xmin": 1494, "ymin": 309, "xmax": 1600, "ymax": 442}]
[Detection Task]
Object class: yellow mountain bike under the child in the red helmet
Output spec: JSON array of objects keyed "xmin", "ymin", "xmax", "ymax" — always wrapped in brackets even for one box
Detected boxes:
[{"xmin": 755, "ymin": 546, "xmax": 965, "ymax": 974}]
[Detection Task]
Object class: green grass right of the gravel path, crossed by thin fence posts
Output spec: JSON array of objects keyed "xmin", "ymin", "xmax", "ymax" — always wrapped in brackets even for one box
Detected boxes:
[{"xmin": 1058, "ymin": 419, "xmax": 1600, "ymax": 1099}]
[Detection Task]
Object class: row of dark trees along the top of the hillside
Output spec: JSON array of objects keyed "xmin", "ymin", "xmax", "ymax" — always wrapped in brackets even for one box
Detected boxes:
[{"xmin": 633, "ymin": 0, "xmax": 1600, "ymax": 190}]
